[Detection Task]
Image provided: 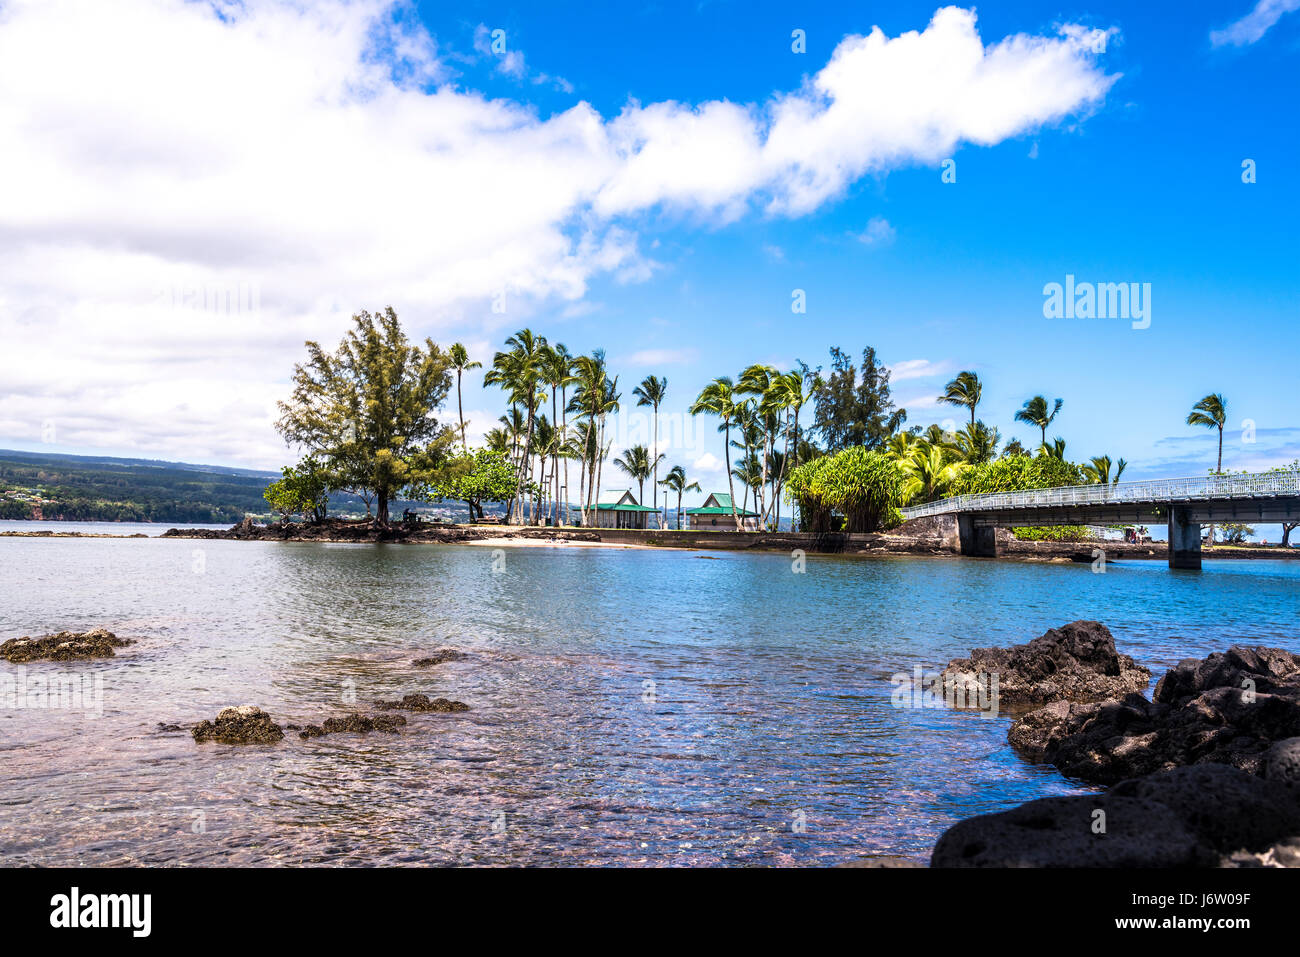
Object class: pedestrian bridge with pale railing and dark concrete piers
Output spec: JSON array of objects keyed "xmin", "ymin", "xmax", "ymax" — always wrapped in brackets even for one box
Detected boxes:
[{"xmin": 902, "ymin": 472, "xmax": 1300, "ymax": 568}]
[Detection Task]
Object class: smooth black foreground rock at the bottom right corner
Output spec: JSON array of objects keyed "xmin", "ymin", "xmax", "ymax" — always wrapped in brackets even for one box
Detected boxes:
[{"xmin": 931, "ymin": 765, "xmax": 1300, "ymax": 867}]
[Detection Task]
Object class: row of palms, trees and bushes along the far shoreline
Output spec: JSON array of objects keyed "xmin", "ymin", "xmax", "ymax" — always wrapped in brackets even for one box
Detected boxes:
[{"xmin": 223, "ymin": 308, "xmax": 1290, "ymax": 556}]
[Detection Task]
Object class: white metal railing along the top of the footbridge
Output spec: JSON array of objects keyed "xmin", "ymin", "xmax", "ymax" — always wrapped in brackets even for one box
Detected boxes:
[{"xmin": 902, "ymin": 471, "xmax": 1300, "ymax": 519}]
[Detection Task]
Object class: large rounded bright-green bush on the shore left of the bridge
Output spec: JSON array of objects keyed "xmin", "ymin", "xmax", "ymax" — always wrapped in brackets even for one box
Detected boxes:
[{"xmin": 787, "ymin": 446, "xmax": 904, "ymax": 532}]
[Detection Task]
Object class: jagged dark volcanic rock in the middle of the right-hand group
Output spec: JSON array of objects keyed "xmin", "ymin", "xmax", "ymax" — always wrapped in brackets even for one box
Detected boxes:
[{"xmin": 1008, "ymin": 645, "xmax": 1300, "ymax": 784}]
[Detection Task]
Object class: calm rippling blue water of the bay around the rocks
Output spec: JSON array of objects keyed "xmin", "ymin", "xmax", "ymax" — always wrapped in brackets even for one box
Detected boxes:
[{"xmin": 0, "ymin": 538, "xmax": 1300, "ymax": 865}]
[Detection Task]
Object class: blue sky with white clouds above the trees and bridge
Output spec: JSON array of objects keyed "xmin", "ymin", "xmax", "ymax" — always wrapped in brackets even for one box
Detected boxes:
[{"xmin": 0, "ymin": 0, "xmax": 1300, "ymax": 509}]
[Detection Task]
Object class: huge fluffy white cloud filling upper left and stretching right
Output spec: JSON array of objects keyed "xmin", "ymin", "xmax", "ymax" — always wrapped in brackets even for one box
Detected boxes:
[{"xmin": 0, "ymin": 0, "xmax": 1114, "ymax": 465}]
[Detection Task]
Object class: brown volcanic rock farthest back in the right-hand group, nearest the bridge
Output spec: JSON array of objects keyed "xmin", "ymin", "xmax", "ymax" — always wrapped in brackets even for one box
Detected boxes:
[{"xmin": 943, "ymin": 622, "xmax": 1151, "ymax": 709}]
